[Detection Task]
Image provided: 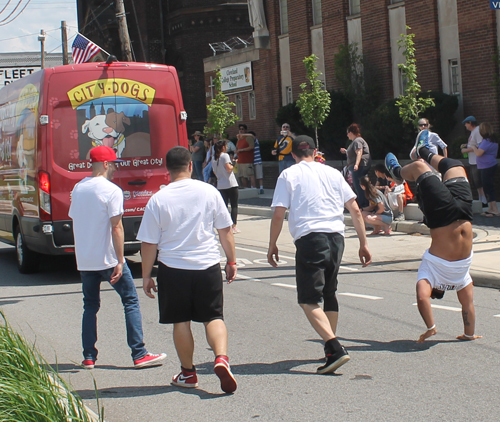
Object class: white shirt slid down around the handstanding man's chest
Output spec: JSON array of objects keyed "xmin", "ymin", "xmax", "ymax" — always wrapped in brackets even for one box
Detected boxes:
[{"xmin": 417, "ymin": 249, "xmax": 472, "ymax": 291}]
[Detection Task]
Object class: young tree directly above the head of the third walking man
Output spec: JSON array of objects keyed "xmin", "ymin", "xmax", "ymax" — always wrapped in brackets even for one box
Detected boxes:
[{"xmin": 297, "ymin": 54, "xmax": 332, "ymax": 148}]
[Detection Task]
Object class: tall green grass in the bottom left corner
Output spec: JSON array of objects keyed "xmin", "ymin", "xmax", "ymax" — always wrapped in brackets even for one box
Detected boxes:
[{"xmin": 0, "ymin": 311, "xmax": 103, "ymax": 422}]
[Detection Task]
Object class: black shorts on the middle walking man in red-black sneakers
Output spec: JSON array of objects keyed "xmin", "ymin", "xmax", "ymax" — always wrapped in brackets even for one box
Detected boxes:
[{"xmin": 157, "ymin": 262, "xmax": 223, "ymax": 324}]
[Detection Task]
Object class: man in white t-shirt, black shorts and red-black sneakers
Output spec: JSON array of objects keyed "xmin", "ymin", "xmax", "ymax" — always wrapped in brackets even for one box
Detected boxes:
[{"xmin": 137, "ymin": 147, "xmax": 236, "ymax": 393}]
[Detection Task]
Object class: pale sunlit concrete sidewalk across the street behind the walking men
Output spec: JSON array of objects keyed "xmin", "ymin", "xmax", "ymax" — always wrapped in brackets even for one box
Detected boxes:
[{"xmin": 237, "ymin": 189, "xmax": 500, "ymax": 288}]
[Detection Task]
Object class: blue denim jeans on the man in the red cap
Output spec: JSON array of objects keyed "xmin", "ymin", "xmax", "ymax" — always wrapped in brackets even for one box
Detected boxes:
[{"xmin": 80, "ymin": 263, "xmax": 147, "ymax": 361}]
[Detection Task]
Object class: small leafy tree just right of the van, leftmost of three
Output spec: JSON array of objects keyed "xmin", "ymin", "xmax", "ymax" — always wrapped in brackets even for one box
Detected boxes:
[{"xmin": 203, "ymin": 68, "xmax": 239, "ymax": 138}]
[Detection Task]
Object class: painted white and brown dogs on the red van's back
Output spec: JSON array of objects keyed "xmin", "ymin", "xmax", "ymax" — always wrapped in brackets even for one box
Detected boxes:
[{"xmin": 82, "ymin": 111, "xmax": 151, "ymax": 159}]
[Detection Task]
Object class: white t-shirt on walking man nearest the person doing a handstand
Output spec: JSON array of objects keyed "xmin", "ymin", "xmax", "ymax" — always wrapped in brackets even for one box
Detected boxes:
[{"xmin": 271, "ymin": 161, "xmax": 356, "ymax": 241}]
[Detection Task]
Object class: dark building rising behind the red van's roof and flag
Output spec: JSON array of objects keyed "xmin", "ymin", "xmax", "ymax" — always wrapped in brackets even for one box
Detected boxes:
[{"xmin": 77, "ymin": 0, "xmax": 252, "ymax": 133}]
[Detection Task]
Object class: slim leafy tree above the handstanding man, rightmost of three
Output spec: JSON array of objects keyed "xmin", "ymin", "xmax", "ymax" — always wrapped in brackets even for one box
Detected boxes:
[{"xmin": 396, "ymin": 26, "xmax": 435, "ymax": 123}]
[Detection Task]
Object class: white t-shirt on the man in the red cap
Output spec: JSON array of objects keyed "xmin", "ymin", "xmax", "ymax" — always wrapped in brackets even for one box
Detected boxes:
[{"xmin": 69, "ymin": 176, "xmax": 123, "ymax": 271}]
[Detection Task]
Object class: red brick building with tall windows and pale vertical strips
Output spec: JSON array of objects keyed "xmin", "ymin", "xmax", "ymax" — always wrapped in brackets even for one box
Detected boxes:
[{"xmin": 204, "ymin": 0, "xmax": 500, "ymax": 139}]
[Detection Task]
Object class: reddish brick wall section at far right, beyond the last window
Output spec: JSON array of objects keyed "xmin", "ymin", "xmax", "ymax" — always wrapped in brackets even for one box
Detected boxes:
[{"xmin": 457, "ymin": 0, "xmax": 500, "ymax": 132}]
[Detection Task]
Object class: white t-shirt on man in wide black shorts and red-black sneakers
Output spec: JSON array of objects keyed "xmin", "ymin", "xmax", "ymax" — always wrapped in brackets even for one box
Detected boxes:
[{"xmin": 137, "ymin": 179, "xmax": 233, "ymax": 270}]
